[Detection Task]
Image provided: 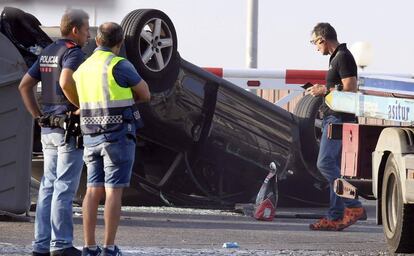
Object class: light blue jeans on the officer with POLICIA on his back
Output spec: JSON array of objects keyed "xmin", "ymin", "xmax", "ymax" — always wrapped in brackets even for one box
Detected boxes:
[{"xmin": 33, "ymin": 132, "xmax": 83, "ymax": 253}]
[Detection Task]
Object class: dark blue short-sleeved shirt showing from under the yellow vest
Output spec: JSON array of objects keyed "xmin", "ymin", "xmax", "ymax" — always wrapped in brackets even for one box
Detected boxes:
[{"xmin": 84, "ymin": 47, "xmax": 142, "ymax": 146}]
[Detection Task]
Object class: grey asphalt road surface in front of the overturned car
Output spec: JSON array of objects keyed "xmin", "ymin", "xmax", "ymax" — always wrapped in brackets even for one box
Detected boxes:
[{"xmin": 0, "ymin": 202, "xmax": 398, "ymax": 255}]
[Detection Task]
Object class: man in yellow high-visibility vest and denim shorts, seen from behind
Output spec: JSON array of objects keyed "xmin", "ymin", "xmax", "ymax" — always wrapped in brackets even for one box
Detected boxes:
[{"xmin": 68, "ymin": 22, "xmax": 150, "ymax": 256}]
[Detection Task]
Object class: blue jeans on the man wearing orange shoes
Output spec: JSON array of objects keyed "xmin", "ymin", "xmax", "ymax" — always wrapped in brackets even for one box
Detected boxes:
[{"xmin": 317, "ymin": 115, "xmax": 361, "ymax": 220}]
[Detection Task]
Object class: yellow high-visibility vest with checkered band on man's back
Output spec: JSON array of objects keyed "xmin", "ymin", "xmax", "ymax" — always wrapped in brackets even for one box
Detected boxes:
[{"xmin": 74, "ymin": 50, "xmax": 134, "ymax": 134}]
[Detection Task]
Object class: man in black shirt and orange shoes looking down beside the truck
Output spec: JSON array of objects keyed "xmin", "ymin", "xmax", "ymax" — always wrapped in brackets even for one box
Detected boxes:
[{"xmin": 307, "ymin": 23, "xmax": 366, "ymax": 231}]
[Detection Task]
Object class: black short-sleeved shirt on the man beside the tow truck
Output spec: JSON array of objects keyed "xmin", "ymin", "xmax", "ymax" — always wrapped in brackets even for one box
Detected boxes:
[{"xmin": 319, "ymin": 44, "xmax": 358, "ymax": 121}]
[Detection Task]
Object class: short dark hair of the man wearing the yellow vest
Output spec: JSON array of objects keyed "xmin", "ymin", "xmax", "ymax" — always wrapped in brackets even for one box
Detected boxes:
[{"xmin": 96, "ymin": 22, "xmax": 124, "ymax": 48}]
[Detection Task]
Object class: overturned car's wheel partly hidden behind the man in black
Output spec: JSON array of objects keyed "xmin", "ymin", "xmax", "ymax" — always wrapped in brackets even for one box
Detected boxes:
[{"xmin": 293, "ymin": 94, "xmax": 326, "ymax": 181}]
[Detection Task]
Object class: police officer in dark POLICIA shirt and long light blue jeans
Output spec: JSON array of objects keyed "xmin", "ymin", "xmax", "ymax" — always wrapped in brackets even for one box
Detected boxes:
[{"xmin": 19, "ymin": 9, "xmax": 89, "ymax": 255}]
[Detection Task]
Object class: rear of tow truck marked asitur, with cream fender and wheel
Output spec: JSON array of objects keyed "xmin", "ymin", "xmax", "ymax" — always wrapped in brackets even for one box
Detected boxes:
[{"xmin": 326, "ymin": 76, "xmax": 414, "ymax": 253}]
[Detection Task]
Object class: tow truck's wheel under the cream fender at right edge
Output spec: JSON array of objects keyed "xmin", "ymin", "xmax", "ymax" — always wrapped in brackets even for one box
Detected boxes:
[{"xmin": 381, "ymin": 154, "xmax": 414, "ymax": 253}]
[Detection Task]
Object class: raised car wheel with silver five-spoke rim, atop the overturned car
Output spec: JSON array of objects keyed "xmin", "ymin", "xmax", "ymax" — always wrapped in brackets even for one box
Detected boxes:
[{"xmin": 121, "ymin": 9, "xmax": 179, "ymax": 80}]
